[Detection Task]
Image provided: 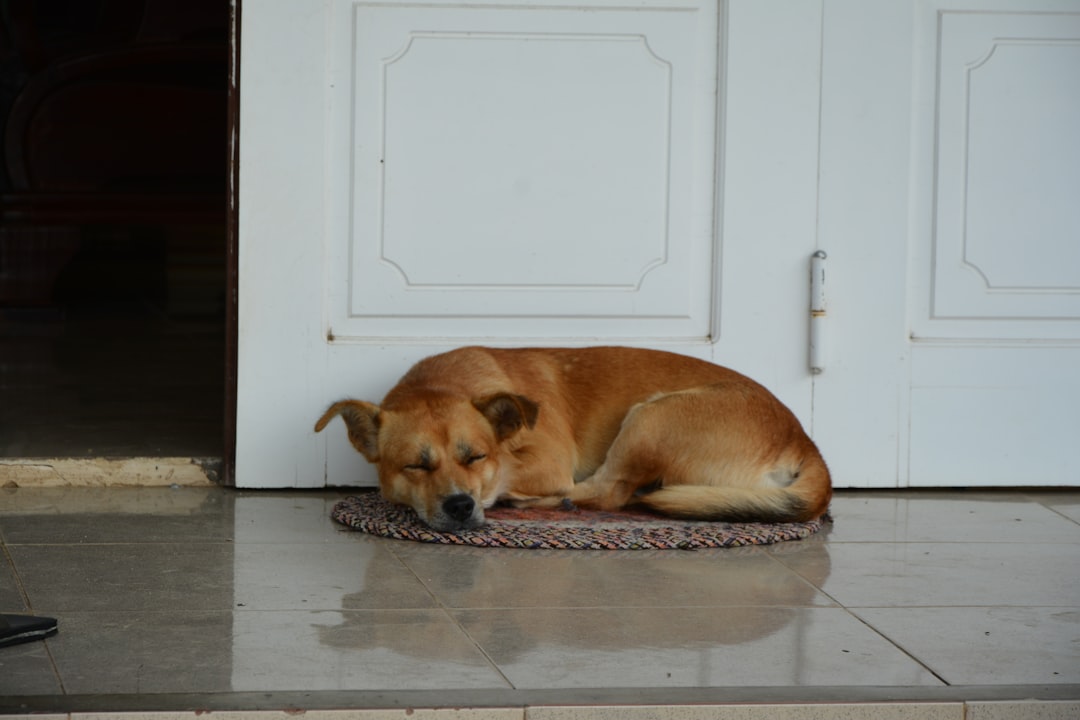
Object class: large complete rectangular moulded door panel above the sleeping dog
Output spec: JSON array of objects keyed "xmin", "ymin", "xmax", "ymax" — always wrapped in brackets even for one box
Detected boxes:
[{"xmin": 327, "ymin": 2, "xmax": 718, "ymax": 342}]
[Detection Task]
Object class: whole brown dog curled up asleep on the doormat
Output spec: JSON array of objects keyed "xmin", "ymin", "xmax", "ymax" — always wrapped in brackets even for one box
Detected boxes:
[{"xmin": 315, "ymin": 348, "xmax": 833, "ymax": 531}]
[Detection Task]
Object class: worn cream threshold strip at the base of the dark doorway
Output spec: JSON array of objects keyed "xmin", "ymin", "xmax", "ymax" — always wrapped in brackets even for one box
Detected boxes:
[{"xmin": 0, "ymin": 458, "xmax": 222, "ymax": 488}]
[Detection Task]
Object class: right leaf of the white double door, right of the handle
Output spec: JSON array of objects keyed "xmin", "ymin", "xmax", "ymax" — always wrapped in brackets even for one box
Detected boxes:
[{"xmin": 813, "ymin": 0, "xmax": 1080, "ymax": 487}]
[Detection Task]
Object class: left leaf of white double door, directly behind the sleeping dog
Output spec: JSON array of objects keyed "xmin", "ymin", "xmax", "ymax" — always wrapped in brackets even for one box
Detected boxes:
[{"xmin": 235, "ymin": 0, "xmax": 821, "ymax": 487}]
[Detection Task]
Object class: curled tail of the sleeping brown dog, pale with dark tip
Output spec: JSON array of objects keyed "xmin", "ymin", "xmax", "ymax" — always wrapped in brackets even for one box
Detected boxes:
[{"xmin": 635, "ymin": 453, "xmax": 833, "ymax": 522}]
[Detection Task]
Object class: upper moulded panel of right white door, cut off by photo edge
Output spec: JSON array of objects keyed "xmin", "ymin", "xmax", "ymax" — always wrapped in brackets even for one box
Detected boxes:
[{"xmin": 913, "ymin": 7, "xmax": 1080, "ymax": 340}]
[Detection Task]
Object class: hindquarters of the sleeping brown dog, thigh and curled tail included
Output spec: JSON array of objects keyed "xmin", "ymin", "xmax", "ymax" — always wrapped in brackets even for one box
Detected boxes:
[{"xmin": 569, "ymin": 383, "xmax": 831, "ymax": 522}]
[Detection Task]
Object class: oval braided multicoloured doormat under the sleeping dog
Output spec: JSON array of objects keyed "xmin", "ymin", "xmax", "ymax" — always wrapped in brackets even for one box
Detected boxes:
[{"xmin": 330, "ymin": 492, "xmax": 832, "ymax": 549}]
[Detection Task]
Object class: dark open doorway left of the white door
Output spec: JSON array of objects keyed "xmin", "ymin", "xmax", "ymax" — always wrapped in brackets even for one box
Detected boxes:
[{"xmin": 0, "ymin": 0, "xmax": 231, "ymax": 472}]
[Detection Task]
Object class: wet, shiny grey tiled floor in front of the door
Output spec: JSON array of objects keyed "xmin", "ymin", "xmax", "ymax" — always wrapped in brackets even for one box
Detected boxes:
[{"xmin": 0, "ymin": 488, "xmax": 1080, "ymax": 720}]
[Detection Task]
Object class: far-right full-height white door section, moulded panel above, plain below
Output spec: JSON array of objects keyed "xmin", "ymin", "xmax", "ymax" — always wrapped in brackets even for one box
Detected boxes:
[{"xmin": 907, "ymin": 0, "xmax": 1080, "ymax": 486}]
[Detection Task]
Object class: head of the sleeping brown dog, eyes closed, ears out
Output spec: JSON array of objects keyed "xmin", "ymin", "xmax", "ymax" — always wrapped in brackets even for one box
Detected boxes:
[{"xmin": 315, "ymin": 391, "xmax": 539, "ymax": 532}]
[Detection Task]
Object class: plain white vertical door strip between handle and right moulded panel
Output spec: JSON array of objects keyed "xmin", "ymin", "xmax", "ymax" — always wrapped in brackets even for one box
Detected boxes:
[{"xmin": 813, "ymin": 0, "xmax": 913, "ymax": 487}]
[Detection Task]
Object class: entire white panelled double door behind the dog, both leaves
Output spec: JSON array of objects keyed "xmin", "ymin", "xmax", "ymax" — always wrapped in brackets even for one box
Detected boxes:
[{"xmin": 235, "ymin": 0, "xmax": 1080, "ymax": 487}]
